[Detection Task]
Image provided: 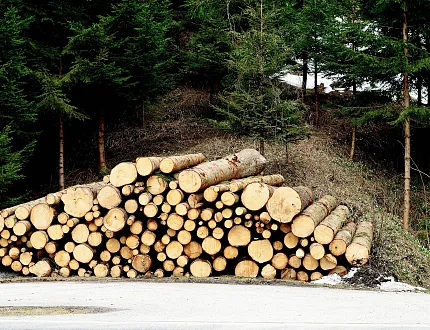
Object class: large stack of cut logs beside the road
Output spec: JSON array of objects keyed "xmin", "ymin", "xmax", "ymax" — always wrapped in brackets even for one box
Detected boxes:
[{"xmin": 0, "ymin": 149, "xmax": 373, "ymax": 281}]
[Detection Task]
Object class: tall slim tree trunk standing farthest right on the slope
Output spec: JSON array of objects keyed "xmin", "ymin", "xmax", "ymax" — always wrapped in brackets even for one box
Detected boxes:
[{"xmin": 402, "ymin": 0, "xmax": 411, "ymax": 230}]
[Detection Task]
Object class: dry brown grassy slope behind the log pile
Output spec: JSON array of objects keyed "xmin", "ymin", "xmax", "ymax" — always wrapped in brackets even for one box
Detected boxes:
[{"xmin": 35, "ymin": 85, "xmax": 430, "ymax": 288}]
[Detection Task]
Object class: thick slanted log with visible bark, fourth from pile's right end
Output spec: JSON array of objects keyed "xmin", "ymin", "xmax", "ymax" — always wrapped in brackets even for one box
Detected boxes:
[{"xmin": 291, "ymin": 195, "xmax": 336, "ymax": 237}]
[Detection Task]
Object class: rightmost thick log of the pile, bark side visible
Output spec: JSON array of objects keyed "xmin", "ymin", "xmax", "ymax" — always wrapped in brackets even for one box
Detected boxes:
[{"xmin": 345, "ymin": 221, "xmax": 373, "ymax": 266}]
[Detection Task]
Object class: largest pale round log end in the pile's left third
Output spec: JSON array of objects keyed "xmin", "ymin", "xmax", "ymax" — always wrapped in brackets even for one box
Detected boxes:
[{"xmin": 60, "ymin": 187, "xmax": 94, "ymax": 218}]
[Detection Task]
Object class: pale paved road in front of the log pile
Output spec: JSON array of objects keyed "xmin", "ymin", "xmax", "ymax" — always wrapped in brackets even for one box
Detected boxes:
[{"xmin": 0, "ymin": 282, "xmax": 430, "ymax": 330}]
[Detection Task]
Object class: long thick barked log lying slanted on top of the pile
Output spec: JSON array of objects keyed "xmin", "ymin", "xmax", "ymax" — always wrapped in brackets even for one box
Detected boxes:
[{"xmin": 178, "ymin": 149, "xmax": 266, "ymax": 193}]
